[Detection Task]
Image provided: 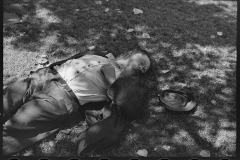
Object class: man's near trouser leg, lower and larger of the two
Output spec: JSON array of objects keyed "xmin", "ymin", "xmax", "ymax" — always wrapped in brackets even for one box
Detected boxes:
[{"xmin": 3, "ymin": 81, "xmax": 79, "ymax": 155}]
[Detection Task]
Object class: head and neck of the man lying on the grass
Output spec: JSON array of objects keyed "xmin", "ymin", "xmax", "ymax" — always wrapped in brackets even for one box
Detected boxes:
[{"xmin": 116, "ymin": 50, "xmax": 151, "ymax": 75}]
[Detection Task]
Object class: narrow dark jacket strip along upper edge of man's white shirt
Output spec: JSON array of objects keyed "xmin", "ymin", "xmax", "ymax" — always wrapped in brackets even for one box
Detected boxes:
[{"xmin": 49, "ymin": 51, "xmax": 108, "ymax": 69}]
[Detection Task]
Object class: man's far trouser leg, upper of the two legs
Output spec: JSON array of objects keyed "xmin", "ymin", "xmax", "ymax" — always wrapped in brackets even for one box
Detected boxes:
[{"xmin": 3, "ymin": 67, "xmax": 57, "ymax": 122}]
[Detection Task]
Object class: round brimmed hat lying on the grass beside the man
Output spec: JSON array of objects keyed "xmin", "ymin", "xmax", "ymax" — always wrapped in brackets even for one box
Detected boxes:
[{"xmin": 158, "ymin": 90, "xmax": 197, "ymax": 112}]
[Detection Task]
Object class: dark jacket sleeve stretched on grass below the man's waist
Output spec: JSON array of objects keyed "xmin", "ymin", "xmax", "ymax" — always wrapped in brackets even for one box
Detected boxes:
[{"xmin": 78, "ymin": 102, "xmax": 126, "ymax": 155}]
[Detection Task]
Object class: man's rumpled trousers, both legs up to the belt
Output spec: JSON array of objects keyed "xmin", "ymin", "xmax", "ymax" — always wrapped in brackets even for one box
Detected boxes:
[{"xmin": 3, "ymin": 67, "xmax": 89, "ymax": 155}]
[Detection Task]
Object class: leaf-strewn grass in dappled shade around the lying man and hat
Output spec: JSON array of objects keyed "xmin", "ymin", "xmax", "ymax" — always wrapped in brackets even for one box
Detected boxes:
[{"xmin": 3, "ymin": 0, "xmax": 237, "ymax": 157}]
